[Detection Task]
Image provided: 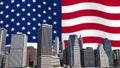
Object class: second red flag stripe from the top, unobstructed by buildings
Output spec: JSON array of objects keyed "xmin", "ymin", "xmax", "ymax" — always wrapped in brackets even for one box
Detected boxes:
[{"xmin": 62, "ymin": 10, "xmax": 120, "ymax": 20}]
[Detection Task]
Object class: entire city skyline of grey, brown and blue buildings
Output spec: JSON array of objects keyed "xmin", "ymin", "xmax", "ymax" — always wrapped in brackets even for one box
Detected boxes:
[{"xmin": 0, "ymin": 24, "xmax": 120, "ymax": 68}]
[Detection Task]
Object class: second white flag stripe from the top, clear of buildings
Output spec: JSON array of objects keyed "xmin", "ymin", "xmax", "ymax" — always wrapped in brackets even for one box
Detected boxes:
[{"xmin": 62, "ymin": 16, "xmax": 120, "ymax": 27}]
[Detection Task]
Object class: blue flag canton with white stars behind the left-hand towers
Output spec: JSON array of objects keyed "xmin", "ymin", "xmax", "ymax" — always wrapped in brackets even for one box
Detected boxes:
[{"xmin": 0, "ymin": 0, "xmax": 61, "ymax": 44}]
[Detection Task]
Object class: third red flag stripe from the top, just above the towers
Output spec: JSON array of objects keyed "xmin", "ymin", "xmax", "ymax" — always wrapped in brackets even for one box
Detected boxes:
[{"xmin": 62, "ymin": 22, "xmax": 120, "ymax": 33}]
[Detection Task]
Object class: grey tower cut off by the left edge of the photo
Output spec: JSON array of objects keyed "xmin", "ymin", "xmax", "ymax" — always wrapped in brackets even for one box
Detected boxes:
[{"xmin": 0, "ymin": 28, "xmax": 7, "ymax": 54}]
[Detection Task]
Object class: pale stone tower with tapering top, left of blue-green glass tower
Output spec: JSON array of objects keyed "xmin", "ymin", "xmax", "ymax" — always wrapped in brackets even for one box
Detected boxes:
[{"xmin": 95, "ymin": 45, "xmax": 109, "ymax": 68}]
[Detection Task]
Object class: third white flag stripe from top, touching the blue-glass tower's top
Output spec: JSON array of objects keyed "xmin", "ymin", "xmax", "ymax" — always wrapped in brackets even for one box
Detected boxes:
[{"xmin": 62, "ymin": 29, "xmax": 120, "ymax": 40}]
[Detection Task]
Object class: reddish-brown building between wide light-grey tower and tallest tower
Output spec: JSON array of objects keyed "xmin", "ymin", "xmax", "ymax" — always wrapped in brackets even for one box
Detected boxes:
[{"xmin": 26, "ymin": 46, "xmax": 37, "ymax": 66}]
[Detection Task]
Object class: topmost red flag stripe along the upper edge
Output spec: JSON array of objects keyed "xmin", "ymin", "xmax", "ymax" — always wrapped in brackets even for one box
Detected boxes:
[{"xmin": 62, "ymin": 0, "xmax": 120, "ymax": 6}]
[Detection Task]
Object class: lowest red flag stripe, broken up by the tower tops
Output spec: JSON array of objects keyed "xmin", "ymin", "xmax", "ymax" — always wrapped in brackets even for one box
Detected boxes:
[{"xmin": 64, "ymin": 36, "xmax": 120, "ymax": 47}]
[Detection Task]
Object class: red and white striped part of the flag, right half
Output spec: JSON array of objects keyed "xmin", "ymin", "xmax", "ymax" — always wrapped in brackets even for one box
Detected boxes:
[{"xmin": 62, "ymin": 0, "xmax": 120, "ymax": 47}]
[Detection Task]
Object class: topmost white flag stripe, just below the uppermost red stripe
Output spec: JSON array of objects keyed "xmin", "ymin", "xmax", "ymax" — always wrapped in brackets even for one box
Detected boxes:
[{"xmin": 62, "ymin": 2, "xmax": 120, "ymax": 13}]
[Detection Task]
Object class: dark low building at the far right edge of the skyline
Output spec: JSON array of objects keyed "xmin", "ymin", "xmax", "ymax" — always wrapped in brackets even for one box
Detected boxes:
[{"xmin": 113, "ymin": 49, "xmax": 120, "ymax": 66}]
